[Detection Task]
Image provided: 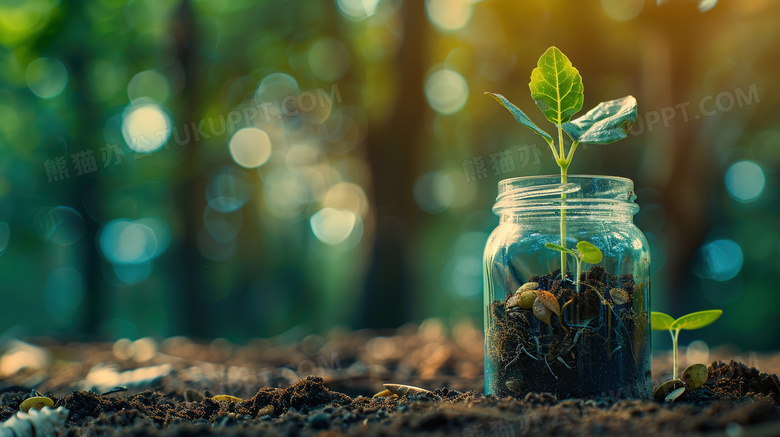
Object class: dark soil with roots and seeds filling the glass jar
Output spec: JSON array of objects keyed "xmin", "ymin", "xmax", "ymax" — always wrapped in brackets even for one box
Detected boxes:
[{"xmin": 486, "ymin": 266, "xmax": 651, "ymax": 399}]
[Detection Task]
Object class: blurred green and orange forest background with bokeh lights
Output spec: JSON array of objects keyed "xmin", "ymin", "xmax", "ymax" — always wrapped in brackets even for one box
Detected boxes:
[{"xmin": 0, "ymin": 0, "xmax": 780, "ymax": 349}]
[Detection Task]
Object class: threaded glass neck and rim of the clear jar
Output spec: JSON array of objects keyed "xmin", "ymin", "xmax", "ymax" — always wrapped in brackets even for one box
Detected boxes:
[{"xmin": 493, "ymin": 175, "xmax": 639, "ymax": 217}]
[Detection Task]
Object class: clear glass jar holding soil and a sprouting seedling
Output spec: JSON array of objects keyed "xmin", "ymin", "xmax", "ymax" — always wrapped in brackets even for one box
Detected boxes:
[{"xmin": 484, "ymin": 175, "xmax": 652, "ymax": 399}]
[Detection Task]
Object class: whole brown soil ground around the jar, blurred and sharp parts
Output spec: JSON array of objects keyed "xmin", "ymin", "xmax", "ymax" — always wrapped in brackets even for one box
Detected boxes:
[{"xmin": 0, "ymin": 321, "xmax": 780, "ymax": 437}]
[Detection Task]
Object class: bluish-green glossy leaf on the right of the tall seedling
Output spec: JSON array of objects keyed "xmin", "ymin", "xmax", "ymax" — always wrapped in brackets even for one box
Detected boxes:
[{"xmin": 562, "ymin": 96, "xmax": 636, "ymax": 144}]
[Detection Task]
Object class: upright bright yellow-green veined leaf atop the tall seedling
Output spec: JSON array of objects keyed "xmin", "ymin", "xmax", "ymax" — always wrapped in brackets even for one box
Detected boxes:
[{"xmin": 528, "ymin": 47, "xmax": 583, "ymax": 124}]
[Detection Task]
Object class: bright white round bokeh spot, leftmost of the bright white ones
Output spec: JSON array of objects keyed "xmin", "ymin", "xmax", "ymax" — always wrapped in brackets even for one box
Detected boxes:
[{"xmin": 122, "ymin": 104, "xmax": 171, "ymax": 153}]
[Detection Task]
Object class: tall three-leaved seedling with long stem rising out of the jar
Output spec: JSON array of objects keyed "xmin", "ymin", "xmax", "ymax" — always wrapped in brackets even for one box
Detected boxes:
[{"xmin": 485, "ymin": 47, "xmax": 637, "ymax": 276}]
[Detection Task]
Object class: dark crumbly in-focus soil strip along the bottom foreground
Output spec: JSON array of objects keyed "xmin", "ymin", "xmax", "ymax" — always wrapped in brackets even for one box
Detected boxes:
[{"xmin": 0, "ymin": 361, "xmax": 780, "ymax": 436}]
